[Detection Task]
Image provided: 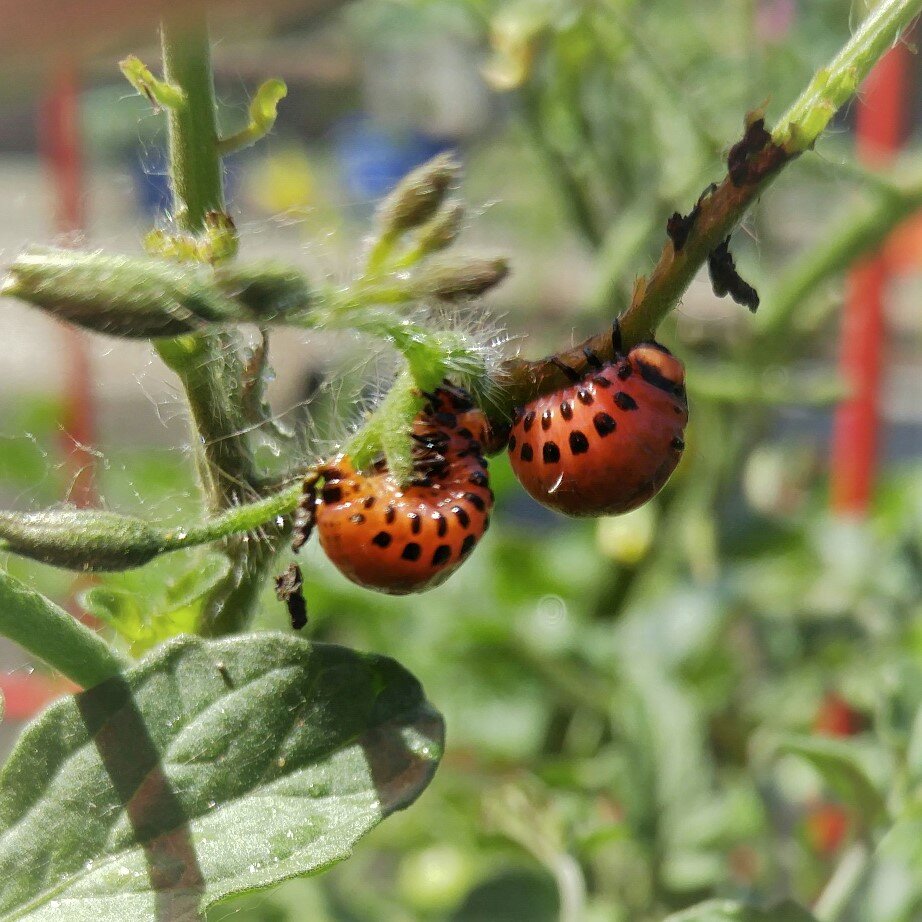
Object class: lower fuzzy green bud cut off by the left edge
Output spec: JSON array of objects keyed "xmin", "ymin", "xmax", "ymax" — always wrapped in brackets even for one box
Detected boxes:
[{"xmin": 0, "ymin": 506, "xmax": 163, "ymax": 571}]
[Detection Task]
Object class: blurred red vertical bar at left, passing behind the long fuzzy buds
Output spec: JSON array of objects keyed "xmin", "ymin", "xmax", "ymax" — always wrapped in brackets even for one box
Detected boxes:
[{"xmin": 39, "ymin": 65, "xmax": 96, "ymax": 506}]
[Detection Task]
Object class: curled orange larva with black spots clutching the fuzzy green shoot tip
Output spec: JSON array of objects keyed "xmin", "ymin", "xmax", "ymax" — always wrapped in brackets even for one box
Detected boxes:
[{"xmin": 314, "ymin": 387, "xmax": 493, "ymax": 595}]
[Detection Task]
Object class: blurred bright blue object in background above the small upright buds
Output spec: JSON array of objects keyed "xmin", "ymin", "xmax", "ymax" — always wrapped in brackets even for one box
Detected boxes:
[{"xmin": 334, "ymin": 115, "xmax": 454, "ymax": 202}]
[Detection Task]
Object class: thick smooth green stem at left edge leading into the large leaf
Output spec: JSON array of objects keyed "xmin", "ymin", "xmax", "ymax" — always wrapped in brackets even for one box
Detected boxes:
[{"xmin": 0, "ymin": 571, "xmax": 127, "ymax": 688}]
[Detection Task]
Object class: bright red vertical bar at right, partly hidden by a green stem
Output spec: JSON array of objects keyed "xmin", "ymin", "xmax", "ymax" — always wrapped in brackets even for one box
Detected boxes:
[{"xmin": 830, "ymin": 42, "xmax": 912, "ymax": 515}]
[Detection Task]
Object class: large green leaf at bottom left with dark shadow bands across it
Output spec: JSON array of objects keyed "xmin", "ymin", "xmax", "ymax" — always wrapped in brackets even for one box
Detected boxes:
[{"xmin": 0, "ymin": 633, "xmax": 443, "ymax": 922}]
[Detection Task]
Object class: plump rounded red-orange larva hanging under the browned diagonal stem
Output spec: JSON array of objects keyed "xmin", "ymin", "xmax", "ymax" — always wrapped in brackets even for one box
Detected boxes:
[{"xmin": 509, "ymin": 343, "xmax": 688, "ymax": 516}]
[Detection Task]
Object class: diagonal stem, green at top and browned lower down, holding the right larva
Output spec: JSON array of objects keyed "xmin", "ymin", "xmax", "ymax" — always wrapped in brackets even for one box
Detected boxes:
[{"xmin": 499, "ymin": 0, "xmax": 922, "ymax": 413}]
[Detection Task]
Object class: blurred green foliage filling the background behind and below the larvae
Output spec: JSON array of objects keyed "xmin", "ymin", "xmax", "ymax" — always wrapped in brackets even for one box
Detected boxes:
[{"xmin": 7, "ymin": 0, "xmax": 922, "ymax": 922}]
